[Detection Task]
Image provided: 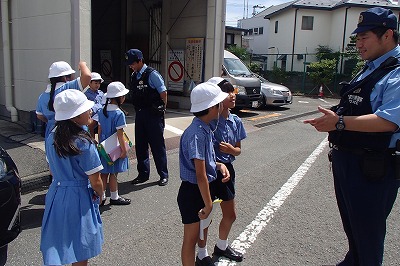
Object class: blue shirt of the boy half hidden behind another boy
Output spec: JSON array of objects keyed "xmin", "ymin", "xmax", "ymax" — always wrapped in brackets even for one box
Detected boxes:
[{"xmin": 210, "ymin": 113, "xmax": 247, "ymax": 163}]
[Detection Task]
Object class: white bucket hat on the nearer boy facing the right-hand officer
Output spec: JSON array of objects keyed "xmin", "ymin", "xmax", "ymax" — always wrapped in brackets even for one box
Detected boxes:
[{"xmin": 190, "ymin": 82, "xmax": 229, "ymax": 113}]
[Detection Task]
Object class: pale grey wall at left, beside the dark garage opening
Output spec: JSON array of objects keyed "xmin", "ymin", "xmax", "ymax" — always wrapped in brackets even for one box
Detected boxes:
[{"xmin": 0, "ymin": 0, "xmax": 91, "ymax": 116}]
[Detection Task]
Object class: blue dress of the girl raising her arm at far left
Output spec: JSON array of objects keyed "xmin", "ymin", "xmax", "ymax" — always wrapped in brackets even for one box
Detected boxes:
[{"xmin": 36, "ymin": 78, "xmax": 83, "ymax": 139}]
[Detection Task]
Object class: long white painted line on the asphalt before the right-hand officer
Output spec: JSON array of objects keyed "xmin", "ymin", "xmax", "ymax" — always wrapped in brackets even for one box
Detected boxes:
[{"xmin": 216, "ymin": 137, "xmax": 328, "ymax": 266}]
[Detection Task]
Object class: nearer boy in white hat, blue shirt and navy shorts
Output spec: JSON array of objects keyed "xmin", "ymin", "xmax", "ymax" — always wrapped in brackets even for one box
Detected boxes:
[{"xmin": 177, "ymin": 82, "xmax": 229, "ymax": 266}]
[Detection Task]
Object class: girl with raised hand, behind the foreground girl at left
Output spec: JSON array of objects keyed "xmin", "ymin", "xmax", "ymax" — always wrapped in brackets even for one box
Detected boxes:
[{"xmin": 36, "ymin": 61, "xmax": 90, "ymax": 139}]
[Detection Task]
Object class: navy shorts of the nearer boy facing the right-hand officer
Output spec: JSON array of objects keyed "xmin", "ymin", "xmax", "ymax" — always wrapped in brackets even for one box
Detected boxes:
[{"xmin": 177, "ymin": 180, "xmax": 217, "ymax": 224}]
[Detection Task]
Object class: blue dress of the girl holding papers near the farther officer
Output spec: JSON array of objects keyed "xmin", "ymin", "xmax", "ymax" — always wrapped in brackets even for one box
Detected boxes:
[{"xmin": 97, "ymin": 104, "xmax": 129, "ymax": 174}]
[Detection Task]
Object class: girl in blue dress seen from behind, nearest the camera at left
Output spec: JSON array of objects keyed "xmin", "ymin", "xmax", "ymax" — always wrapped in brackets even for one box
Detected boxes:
[{"xmin": 40, "ymin": 90, "xmax": 103, "ymax": 266}]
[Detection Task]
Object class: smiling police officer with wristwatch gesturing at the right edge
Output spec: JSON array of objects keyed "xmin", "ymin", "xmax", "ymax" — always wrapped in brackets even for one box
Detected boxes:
[{"xmin": 304, "ymin": 7, "xmax": 400, "ymax": 265}]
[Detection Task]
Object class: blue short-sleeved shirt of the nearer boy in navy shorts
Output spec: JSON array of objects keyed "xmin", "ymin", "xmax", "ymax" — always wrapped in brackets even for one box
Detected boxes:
[{"xmin": 179, "ymin": 117, "xmax": 217, "ymax": 184}]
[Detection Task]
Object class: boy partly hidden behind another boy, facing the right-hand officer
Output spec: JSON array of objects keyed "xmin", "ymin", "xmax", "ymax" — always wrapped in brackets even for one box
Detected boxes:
[{"xmin": 208, "ymin": 77, "xmax": 247, "ymax": 262}]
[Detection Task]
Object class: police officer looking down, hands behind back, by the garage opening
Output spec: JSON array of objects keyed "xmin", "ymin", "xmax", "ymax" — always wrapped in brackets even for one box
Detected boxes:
[{"xmin": 125, "ymin": 49, "xmax": 168, "ymax": 186}]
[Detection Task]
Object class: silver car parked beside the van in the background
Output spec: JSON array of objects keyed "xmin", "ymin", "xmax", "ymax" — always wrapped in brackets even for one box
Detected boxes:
[{"xmin": 254, "ymin": 73, "xmax": 293, "ymax": 107}]
